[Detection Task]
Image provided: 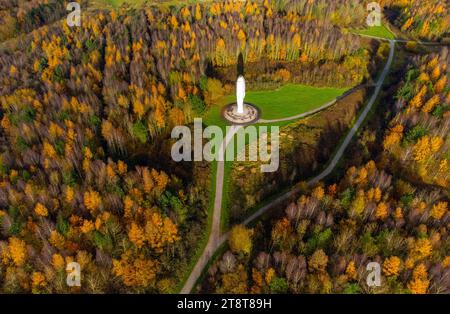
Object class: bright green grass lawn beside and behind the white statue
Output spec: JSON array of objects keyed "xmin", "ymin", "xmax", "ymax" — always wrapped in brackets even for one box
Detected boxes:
[{"xmin": 218, "ymin": 84, "xmax": 347, "ymax": 119}]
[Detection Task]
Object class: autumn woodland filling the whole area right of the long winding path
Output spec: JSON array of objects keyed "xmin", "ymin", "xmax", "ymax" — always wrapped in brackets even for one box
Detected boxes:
[{"xmin": 203, "ymin": 48, "xmax": 450, "ymax": 294}]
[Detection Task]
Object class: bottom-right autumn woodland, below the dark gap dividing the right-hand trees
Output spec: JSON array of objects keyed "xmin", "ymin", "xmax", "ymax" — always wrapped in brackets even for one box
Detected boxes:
[{"xmin": 204, "ymin": 161, "xmax": 450, "ymax": 293}]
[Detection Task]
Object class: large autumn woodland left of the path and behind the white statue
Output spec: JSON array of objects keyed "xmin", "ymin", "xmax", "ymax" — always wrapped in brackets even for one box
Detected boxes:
[{"xmin": 0, "ymin": 1, "xmax": 374, "ymax": 293}]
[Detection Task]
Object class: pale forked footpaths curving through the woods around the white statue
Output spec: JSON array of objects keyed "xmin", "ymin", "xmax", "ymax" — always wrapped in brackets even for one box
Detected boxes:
[{"xmin": 180, "ymin": 37, "xmax": 396, "ymax": 294}]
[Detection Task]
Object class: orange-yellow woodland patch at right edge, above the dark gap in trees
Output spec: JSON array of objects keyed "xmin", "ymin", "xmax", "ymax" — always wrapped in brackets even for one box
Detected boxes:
[{"xmin": 383, "ymin": 49, "xmax": 450, "ymax": 189}]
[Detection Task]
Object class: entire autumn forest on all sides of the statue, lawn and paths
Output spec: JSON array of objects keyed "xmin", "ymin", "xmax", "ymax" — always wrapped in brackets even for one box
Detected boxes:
[{"xmin": 0, "ymin": 0, "xmax": 450, "ymax": 294}]
